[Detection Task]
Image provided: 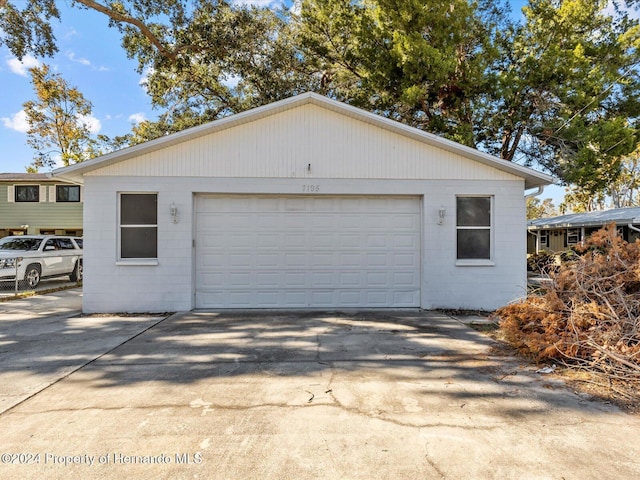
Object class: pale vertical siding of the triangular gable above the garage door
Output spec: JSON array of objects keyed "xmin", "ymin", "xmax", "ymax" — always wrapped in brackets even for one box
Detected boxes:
[{"xmin": 87, "ymin": 104, "xmax": 519, "ymax": 180}]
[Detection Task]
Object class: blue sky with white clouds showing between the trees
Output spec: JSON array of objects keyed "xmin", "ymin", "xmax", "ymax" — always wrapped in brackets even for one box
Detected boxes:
[{"xmin": 0, "ymin": 0, "xmax": 562, "ymax": 202}]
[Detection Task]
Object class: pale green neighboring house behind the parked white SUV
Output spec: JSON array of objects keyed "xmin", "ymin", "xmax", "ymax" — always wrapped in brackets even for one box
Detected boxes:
[{"xmin": 0, "ymin": 173, "xmax": 83, "ymax": 237}]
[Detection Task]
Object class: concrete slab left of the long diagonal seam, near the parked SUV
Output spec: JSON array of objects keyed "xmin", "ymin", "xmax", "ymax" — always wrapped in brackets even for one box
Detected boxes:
[{"xmin": 0, "ymin": 288, "xmax": 168, "ymax": 414}]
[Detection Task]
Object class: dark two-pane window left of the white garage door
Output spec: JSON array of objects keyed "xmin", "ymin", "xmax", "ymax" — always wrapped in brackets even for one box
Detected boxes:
[{"xmin": 120, "ymin": 193, "xmax": 158, "ymax": 259}]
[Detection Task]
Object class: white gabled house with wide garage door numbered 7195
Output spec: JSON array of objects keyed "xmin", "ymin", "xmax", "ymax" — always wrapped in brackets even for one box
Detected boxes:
[{"xmin": 54, "ymin": 93, "xmax": 553, "ymax": 312}]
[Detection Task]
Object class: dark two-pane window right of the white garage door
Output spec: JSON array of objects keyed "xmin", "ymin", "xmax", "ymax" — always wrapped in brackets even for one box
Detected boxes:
[{"xmin": 456, "ymin": 197, "xmax": 491, "ymax": 260}]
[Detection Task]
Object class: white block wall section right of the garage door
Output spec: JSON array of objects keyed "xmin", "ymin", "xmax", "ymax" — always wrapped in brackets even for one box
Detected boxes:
[{"xmin": 422, "ymin": 181, "xmax": 526, "ymax": 310}]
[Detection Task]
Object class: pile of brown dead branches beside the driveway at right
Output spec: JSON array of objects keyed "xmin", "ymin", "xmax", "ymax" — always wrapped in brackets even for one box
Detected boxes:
[{"xmin": 496, "ymin": 225, "xmax": 640, "ymax": 381}]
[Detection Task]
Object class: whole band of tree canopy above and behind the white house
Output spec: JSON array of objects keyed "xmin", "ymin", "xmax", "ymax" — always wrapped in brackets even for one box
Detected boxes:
[{"xmin": 0, "ymin": 0, "xmax": 640, "ymax": 192}]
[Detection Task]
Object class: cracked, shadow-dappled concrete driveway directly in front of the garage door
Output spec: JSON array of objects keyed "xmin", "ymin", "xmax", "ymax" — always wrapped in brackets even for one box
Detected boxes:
[{"xmin": 0, "ymin": 300, "xmax": 640, "ymax": 480}]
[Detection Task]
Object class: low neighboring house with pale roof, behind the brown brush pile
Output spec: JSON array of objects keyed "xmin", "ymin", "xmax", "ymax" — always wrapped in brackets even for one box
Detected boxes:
[{"xmin": 527, "ymin": 207, "xmax": 640, "ymax": 253}]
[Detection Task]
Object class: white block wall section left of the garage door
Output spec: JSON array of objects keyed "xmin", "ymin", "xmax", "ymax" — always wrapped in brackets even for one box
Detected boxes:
[{"xmin": 83, "ymin": 177, "xmax": 193, "ymax": 313}]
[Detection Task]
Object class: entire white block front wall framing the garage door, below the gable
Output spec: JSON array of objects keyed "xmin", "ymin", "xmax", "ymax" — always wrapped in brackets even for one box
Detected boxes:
[{"xmin": 83, "ymin": 176, "xmax": 526, "ymax": 313}]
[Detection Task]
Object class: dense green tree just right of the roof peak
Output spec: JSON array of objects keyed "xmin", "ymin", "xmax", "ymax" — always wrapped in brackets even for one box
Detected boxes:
[{"xmin": 299, "ymin": 0, "xmax": 495, "ymax": 146}]
